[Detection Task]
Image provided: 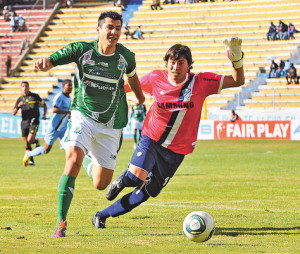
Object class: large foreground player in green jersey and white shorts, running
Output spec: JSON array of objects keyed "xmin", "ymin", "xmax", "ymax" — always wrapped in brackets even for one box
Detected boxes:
[{"xmin": 35, "ymin": 11, "xmax": 145, "ymax": 237}]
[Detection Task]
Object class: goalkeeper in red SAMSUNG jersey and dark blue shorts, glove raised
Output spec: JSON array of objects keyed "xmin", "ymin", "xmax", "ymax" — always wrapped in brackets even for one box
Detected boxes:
[{"xmin": 93, "ymin": 38, "xmax": 245, "ymax": 228}]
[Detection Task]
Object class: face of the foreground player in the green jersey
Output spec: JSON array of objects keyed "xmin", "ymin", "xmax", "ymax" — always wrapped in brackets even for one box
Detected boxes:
[{"xmin": 97, "ymin": 18, "xmax": 122, "ymax": 47}]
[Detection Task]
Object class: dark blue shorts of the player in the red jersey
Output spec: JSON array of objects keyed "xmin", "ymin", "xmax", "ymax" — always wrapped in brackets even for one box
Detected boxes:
[{"xmin": 130, "ymin": 136, "xmax": 184, "ymax": 197}]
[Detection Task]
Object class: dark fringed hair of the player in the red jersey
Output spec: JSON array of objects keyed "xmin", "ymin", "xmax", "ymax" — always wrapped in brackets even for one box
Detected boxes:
[{"xmin": 163, "ymin": 44, "xmax": 194, "ymax": 71}]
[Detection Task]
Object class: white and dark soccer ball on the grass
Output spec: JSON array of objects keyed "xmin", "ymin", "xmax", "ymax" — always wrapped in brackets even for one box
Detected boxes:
[{"xmin": 183, "ymin": 211, "xmax": 215, "ymax": 242}]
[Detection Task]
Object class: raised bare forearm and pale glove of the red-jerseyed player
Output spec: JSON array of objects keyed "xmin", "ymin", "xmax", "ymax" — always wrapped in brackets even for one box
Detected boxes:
[{"xmin": 223, "ymin": 37, "xmax": 245, "ymax": 88}]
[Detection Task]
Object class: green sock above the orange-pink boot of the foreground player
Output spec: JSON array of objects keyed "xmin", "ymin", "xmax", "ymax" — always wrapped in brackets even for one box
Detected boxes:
[{"xmin": 56, "ymin": 174, "xmax": 76, "ymax": 225}]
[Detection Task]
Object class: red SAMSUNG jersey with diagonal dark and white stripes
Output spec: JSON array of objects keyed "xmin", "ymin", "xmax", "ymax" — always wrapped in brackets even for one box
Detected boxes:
[{"xmin": 140, "ymin": 70, "xmax": 223, "ymax": 154}]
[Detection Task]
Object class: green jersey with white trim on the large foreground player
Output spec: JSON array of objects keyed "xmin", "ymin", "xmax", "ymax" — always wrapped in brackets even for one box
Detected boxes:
[{"xmin": 50, "ymin": 40, "xmax": 136, "ymax": 129}]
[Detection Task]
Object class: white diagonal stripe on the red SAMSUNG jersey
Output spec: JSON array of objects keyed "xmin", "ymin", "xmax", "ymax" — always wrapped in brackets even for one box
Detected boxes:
[{"xmin": 162, "ymin": 75, "xmax": 196, "ymax": 148}]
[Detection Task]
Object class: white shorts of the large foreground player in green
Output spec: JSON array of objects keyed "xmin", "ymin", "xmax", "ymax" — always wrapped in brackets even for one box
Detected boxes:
[{"xmin": 62, "ymin": 110, "xmax": 122, "ymax": 170}]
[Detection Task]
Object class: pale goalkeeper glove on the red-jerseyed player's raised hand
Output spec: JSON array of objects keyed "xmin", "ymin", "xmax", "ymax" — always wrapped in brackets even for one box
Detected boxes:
[{"xmin": 224, "ymin": 37, "xmax": 244, "ymax": 69}]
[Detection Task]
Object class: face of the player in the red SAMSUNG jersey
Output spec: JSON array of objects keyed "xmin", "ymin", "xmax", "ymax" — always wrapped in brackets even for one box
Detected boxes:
[{"xmin": 167, "ymin": 56, "xmax": 190, "ymax": 84}]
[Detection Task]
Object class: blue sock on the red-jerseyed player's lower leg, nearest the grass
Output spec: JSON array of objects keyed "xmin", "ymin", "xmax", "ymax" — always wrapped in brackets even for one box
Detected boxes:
[{"xmin": 97, "ymin": 187, "xmax": 150, "ymax": 219}]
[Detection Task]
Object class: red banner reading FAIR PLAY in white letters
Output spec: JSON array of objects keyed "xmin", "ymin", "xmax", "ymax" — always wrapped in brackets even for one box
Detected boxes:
[{"xmin": 214, "ymin": 121, "xmax": 291, "ymax": 140}]
